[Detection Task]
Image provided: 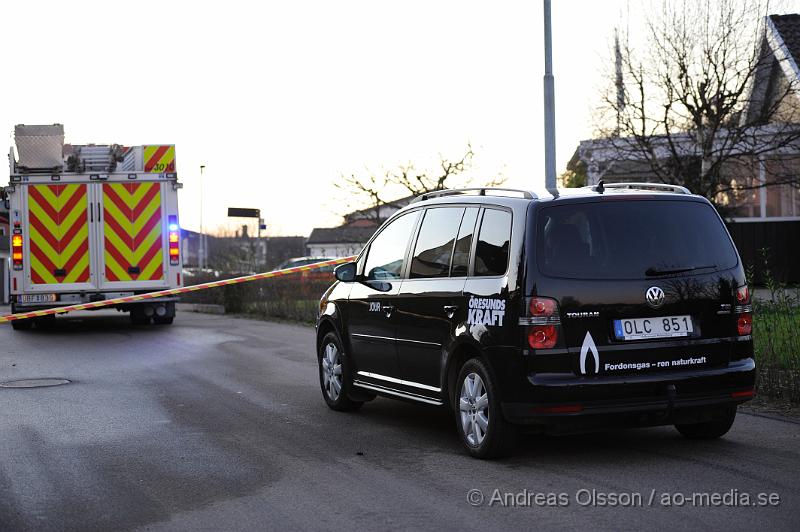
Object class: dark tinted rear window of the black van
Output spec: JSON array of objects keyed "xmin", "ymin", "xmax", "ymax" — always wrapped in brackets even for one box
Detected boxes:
[{"xmin": 536, "ymin": 200, "xmax": 738, "ymax": 279}]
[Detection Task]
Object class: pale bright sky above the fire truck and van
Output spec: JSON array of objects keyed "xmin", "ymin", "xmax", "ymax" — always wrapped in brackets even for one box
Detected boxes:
[{"xmin": 0, "ymin": 0, "xmax": 800, "ymax": 236}]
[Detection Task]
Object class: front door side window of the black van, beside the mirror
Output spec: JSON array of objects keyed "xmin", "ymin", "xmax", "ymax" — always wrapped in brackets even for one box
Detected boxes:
[{"xmin": 364, "ymin": 212, "xmax": 419, "ymax": 281}]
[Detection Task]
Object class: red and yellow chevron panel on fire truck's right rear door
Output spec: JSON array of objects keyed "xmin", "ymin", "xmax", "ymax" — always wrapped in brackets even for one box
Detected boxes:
[{"xmin": 103, "ymin": 183, "xmax": 164, "ymax": 281}]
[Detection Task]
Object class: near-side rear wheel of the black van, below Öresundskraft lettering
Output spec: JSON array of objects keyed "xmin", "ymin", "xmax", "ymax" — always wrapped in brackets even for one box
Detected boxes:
[{"xmin": 454, "ymin": 358, "xmax": 517, "ymax": 459}]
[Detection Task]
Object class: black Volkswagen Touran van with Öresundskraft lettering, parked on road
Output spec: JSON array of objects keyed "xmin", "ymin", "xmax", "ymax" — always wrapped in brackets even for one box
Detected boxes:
[{"xmin": 317, "ymin": 186, "xmax": 755, "ymax": 457}]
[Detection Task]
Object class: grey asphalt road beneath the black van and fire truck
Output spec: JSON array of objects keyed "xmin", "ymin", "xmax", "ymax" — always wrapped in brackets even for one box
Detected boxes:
[{"xmin": 0, "ymin": 311, "xmax": 800, "ymax": 531}]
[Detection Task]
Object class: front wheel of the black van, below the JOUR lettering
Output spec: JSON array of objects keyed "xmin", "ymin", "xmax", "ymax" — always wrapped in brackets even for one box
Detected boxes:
[{"xmin": 317, "ymin": 332, "xmax": 364, "ymax": 412}]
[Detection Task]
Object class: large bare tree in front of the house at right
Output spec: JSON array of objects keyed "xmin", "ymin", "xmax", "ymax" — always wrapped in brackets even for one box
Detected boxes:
[{"xmin": 596, "ymin": 0, "xmax": 800, "ymax": 210}]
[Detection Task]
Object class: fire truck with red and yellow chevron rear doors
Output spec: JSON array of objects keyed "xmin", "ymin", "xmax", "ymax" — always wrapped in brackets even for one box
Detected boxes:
[{"xmin": 2, "ymin": 124, "xmax": 182, "ymax": 329}]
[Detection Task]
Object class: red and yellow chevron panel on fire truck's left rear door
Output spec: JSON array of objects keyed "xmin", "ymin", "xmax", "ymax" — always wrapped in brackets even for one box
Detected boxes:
[{"xmin": 28, "ymin": 184, "xmax": 89, "ymax": 285}]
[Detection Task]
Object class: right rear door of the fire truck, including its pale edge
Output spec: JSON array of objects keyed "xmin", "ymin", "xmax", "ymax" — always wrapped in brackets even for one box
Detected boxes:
[{"xmin": 98, "ymin": 181, "xmax": 171, "ymax": 289}]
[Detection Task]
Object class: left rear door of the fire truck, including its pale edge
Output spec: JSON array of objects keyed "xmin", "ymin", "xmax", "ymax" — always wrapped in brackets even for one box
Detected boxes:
[{"xmin": 21, "ymin": 183, "xmax": 97, "ymax": 292}]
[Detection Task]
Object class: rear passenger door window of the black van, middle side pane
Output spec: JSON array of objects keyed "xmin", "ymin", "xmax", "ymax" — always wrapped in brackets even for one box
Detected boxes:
[{"xmin": 410, "ymin": 207, "xmax": 464, "ymax": 279}]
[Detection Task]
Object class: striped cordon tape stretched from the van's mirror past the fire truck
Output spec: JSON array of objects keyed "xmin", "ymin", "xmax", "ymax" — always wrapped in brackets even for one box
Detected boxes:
[{"xmin": 0, "ymin": 257, "xmax": 355, "ymax": 323}]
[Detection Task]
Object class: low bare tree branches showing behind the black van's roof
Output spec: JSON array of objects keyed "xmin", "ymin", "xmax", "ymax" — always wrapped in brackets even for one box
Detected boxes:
[{"xmin": 336, "ymin": 144, "xmax": 505, "ymax": 222}]
